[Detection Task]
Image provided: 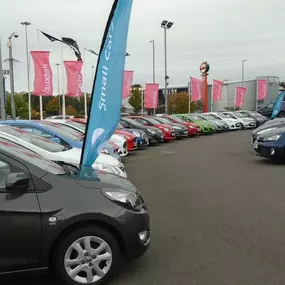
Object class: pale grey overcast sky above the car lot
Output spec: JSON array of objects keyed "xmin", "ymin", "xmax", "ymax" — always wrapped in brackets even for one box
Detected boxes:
[{"xmin": 0, "ymin": 0, "xmax": 285, "ymax": 92}]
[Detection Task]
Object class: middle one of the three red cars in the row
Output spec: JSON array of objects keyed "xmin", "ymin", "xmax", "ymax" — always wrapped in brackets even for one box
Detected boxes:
[{"xmin": 129, "ymin": 116, "xmax": 176, "ymax": 141}]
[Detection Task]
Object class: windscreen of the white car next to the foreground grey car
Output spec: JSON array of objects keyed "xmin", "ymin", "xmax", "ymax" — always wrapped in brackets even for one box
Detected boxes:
[{"xmin": 0, "ymin": 126, "xmax": 65, "ymax": 152}]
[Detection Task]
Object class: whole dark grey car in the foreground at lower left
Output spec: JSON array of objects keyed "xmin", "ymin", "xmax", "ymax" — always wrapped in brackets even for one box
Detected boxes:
[{"xmin": 0, "ymin": 138, "xmax": 150, "ymax": 285}]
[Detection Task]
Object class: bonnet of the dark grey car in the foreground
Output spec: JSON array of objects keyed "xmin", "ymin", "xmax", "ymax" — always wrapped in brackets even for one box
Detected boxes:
[{"xmin": 73, "ymin": 170, "xmax": 138, "ymax": 193}]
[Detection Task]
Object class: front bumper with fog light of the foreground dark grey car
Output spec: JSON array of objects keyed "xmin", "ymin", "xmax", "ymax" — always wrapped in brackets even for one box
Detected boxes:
[{"xmin": 115, "ymin": 206, "xmax": 150, "ymax": 260}]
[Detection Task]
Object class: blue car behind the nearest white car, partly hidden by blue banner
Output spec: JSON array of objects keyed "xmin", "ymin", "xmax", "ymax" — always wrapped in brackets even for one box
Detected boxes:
[{"xmin": 0, "ymin": 120, "xmax": 121, "ymax": 161}]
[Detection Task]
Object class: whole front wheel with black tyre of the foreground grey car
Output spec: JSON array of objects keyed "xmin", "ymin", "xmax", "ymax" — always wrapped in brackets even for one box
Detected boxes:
[{"xmin": 54, "ymin": 226, "xmax": 122, "ymax": 285}]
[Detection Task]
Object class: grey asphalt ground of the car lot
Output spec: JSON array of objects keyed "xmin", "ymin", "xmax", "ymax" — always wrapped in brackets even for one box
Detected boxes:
[{"xmin": 4, "ymin": 131, "xmax": 285, "ymax": 285}]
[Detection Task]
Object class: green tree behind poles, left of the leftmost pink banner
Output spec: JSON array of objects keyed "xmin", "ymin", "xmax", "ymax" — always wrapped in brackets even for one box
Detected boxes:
[{"xmin": 6, "ymin": 93, "xmax": 29, "ymax": 119}]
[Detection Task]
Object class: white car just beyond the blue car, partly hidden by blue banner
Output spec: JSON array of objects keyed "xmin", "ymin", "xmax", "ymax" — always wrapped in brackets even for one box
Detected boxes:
[{"xmin": 46, "ymin": 119, "xmax": 128, "ymax": 156}]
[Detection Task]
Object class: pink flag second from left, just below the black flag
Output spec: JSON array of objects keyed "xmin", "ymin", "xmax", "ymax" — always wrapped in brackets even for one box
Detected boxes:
[{"xmin": 64, "ymin": 60, "xmax": 83, "ymax": 97}]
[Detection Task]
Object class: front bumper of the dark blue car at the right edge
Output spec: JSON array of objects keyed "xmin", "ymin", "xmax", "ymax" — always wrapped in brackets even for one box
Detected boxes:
[{"xmin": 253, "ymin": 141, "xmax": 284, "ymax": 159}]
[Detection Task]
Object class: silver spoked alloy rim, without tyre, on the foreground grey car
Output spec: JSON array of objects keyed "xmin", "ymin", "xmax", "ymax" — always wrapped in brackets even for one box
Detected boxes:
[{"xmin": 64, "ymin": 236, "xmax": 113, "ymax": 284}]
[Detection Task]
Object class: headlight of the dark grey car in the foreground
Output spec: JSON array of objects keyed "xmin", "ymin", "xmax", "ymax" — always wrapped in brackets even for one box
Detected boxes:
[{"xmin": 102, "ymin": 189, "xmax": 143, "ymax": 212}]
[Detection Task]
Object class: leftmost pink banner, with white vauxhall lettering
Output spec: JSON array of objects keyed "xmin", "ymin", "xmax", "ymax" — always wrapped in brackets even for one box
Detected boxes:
[{"xmin": 31, "ymin": 51, "xmax": 53, "ymax": 96}]
